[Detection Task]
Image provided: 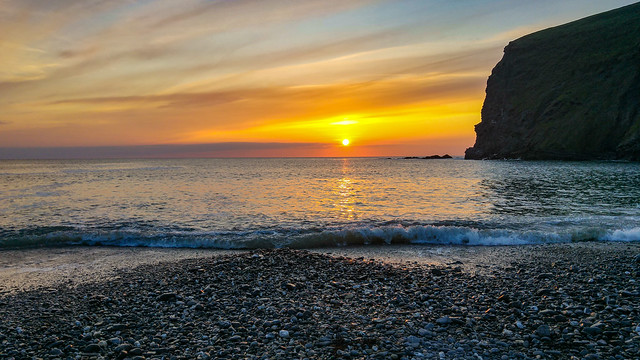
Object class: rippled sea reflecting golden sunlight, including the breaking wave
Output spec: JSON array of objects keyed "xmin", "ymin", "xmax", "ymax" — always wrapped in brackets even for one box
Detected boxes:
[{"xmin": 0, "ymin": 158, "xmax": 640, "ymax": 248}]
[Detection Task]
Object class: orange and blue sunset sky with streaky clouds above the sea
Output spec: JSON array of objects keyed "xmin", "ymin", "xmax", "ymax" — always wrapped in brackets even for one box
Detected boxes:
[{"xmin": 0, "ymin": 0, "xmax": 635, "ymax": 158}]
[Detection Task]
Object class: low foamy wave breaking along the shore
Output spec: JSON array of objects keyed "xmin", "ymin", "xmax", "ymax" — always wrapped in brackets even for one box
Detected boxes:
[{"xmin": 0, "ymin": 224, "xmax": 640, "ymax": 249}]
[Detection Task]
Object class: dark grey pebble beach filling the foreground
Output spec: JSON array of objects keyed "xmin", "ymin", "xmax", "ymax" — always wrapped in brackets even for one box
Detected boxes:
[{"xmin": 0, "ymin": 244, "xmax": 640, "ymax": 359}]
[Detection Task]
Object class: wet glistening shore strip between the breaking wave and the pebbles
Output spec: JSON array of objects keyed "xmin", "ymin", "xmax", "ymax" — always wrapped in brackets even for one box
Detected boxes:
[{"xmin": 0, "ymin": 242, "xmax": 640, "ymax": 296}]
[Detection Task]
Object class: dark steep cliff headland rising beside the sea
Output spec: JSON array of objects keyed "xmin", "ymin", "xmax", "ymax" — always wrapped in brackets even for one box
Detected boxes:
[{"xmin": 465, "ymin": 3, "xmax": 640, "ymax": 161}]
